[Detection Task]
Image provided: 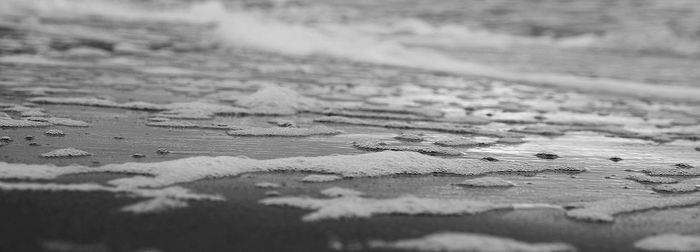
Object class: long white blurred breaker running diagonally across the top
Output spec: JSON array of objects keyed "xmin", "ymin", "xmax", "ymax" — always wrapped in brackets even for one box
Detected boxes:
[{"xmin": 0, "ymin": 0, "xmax": 700, "ymax": 102}]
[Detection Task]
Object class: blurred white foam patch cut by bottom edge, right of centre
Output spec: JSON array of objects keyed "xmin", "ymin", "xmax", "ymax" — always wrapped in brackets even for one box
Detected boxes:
[{"xmin": 368, "ymin": 232, "xmax": 576, "ymax": 252}]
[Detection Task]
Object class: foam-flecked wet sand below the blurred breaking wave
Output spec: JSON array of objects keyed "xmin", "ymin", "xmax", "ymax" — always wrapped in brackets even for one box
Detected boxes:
[{"xmin": 0, "ymin": 1, "xmax": 700, "ymax": 251}]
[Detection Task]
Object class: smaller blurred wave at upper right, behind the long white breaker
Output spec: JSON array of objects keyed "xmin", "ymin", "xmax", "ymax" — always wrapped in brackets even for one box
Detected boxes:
[{"xmin": 344, "ymin": 18, "xmax": 700, "ymax": 57}]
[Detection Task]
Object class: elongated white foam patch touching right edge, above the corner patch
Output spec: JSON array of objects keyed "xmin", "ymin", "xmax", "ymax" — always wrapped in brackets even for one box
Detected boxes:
[{"xmin": 566, "ymin": 196, "xmax": 700, "ymax": 222}]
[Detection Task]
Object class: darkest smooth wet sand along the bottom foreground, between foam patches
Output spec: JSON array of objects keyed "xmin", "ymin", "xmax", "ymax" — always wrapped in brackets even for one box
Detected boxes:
[{"xmin": 0, "ymin": 173, "xmax": 700, "ymax": 251}]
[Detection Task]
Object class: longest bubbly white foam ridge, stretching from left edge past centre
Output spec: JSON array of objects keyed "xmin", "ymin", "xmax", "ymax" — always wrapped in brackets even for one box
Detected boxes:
[{"xmin": 0, "ymin": 151, "xmax": 586, "ymax": 187}]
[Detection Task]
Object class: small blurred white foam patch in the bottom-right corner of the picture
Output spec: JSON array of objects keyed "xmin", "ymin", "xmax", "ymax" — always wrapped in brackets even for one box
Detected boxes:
[{"xmin": 634, "ymin": 234, "xmax": 700, "ymax": 252}]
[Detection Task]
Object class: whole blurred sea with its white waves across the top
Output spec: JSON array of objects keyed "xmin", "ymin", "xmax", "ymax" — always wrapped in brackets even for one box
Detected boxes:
[{"xmin": 0, "ymin": 0, "xmax": 700, "ymax": 101}]
